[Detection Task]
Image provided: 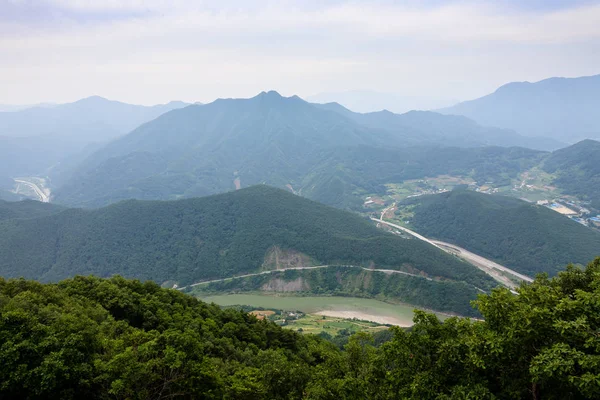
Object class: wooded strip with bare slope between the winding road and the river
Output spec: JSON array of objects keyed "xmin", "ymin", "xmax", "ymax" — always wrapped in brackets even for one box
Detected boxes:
[{"xmin": 193, "ymin": 266, "xmax": 480, "ymax": 316}]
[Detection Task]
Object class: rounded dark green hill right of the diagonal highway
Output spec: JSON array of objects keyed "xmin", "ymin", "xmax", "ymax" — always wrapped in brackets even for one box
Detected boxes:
[{"xmin": 404, "ymin": 190, "xmax": 600, "ymax": 276}]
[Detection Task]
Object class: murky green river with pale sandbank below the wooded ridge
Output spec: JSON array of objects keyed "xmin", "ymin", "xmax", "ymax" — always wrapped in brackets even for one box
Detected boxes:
[{"xmin": 202, "ymin": 294, "xmax": 434, "ymax": 326}]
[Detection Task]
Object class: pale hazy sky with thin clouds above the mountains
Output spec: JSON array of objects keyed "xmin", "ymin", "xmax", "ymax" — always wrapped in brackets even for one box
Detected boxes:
[{"xmin": 0, "ymin": 0, "xmax": 600, "ymax": 104}]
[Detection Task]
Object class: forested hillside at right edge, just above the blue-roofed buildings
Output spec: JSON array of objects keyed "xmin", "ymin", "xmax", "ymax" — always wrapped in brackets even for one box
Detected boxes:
[{"xmin": 543, "ymin": 140, "xmax": 600, "ymax": 212}]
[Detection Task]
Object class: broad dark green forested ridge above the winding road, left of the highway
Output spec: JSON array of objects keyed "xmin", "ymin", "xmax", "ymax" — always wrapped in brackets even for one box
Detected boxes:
[{"xmin": 0, "ymin": 185, "xmax": 493, "ymax": 289}]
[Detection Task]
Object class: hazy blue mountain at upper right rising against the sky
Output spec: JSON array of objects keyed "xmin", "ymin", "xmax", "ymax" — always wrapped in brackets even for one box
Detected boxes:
[{"xmin": 438, "ymin": 75, "xmax": 600, "ymax": 143}]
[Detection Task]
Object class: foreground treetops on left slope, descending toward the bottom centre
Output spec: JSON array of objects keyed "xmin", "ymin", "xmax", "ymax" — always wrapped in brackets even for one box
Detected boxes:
[{"xmin": 0, "ymin": 277, "xmax": 332, "ymax": 399}]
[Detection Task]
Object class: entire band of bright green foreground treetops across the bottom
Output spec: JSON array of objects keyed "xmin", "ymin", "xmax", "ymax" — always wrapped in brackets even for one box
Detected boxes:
[{"xmin": 0, "ymin": 258, "xmax": 600, "ymax": 400}]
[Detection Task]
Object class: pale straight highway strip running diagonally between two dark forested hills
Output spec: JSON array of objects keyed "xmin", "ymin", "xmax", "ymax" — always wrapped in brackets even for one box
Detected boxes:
[{"xmin": 371, "ymin": 218, "xmax": 533, "ymax": 288}]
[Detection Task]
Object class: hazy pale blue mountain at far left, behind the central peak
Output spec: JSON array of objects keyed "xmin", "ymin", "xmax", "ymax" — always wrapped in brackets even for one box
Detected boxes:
[{"xmin": 0, "ymin": 96, "xmax": 188, "ymax": 176}]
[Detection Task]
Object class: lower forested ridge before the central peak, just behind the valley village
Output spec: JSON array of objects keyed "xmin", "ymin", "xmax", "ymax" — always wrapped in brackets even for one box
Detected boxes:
[{"xmin": 298, "ymin": 146, "xmax": 548, "ymax": 210}]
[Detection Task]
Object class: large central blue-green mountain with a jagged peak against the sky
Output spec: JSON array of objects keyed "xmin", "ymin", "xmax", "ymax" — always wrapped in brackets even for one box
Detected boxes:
[{"xmin": 55, "ymin": 92, "xmax": 556, "ymax": 206}]
